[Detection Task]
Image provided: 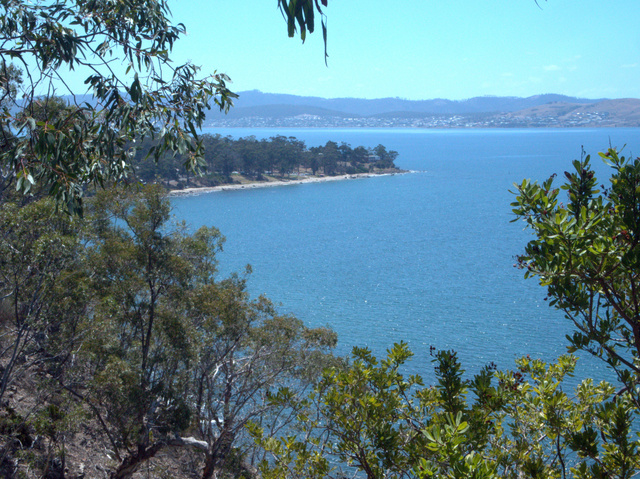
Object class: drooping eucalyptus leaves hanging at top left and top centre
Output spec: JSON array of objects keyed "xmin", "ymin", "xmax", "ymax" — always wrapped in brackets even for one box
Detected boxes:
[{"xmin": 0, "ymin": 0, "xmax": 326, "ymax": 211}]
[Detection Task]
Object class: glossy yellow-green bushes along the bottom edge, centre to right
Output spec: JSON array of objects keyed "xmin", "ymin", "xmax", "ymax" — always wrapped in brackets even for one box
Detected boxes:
[{"xmin": 252, "ymin": 344, "xmax": 640, "ymax": 479}]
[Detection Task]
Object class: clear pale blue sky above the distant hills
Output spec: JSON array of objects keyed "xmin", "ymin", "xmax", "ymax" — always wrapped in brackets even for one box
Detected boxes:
[{"xmin": 170, "ymin": 0, "xmax": 640, "ymax": 100}]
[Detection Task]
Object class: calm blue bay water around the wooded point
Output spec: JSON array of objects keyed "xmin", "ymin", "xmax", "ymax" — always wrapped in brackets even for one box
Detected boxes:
[{"xmin": 173, "ymin": 129, "xmax": 640, "ymax": 384}]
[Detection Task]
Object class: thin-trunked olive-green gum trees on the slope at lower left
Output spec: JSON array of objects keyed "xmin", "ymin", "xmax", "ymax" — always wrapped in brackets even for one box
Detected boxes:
[{"xmin": 0, "ymin": 185, "xmax": 339, "ymax": 479}]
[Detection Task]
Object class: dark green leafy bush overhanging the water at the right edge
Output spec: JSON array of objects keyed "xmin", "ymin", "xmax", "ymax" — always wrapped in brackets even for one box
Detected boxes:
[{"xmin": 513, "ymin": 149, "xmax": 640, "ymax": 406}]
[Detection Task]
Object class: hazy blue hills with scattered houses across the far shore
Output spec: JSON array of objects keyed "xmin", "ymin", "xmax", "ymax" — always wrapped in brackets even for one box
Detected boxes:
[{"xmin": 206, "ymin": 90, "xmax": 640, "ymax": 127}]
